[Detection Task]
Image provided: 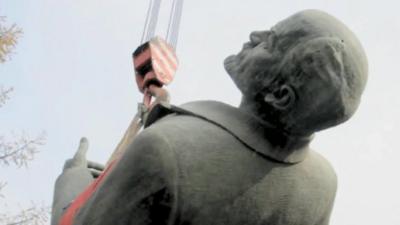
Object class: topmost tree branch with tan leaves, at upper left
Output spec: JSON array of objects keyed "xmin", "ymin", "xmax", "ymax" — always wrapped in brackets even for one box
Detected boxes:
[{"xmin": 0, "ymin": 17, "xmax": 22, "ymax": 63}]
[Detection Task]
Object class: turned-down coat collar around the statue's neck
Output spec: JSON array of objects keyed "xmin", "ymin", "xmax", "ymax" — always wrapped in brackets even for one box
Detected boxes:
[{"xmin": 145, "ymin": 101, "xmax": 312, "ymax": 163}]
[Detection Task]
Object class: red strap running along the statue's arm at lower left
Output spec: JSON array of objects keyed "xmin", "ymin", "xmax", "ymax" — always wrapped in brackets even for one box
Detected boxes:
[{"xmin": 59, "ymin": 161, "xmax": 115, "ymax": 225}]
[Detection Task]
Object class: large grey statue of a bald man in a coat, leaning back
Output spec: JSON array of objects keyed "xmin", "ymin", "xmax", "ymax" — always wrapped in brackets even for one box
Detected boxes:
[{"xmin": 53, "ymin": 10, "xmax": 368, "ymax": 225}]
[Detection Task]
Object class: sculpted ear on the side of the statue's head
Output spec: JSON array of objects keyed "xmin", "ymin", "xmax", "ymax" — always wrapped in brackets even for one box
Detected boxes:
[{"xmin": 264, "ymin": 84, "xmax": 296, "ymax": 110}]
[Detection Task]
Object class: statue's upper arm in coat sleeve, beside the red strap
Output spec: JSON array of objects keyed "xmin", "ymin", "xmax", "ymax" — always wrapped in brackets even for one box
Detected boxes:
[{"xmin": 75, "ymin": 129, "xmax": 177, "ymax": 225}]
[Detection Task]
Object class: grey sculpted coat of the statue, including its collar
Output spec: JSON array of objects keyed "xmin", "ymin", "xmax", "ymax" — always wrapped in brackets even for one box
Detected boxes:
[{"xmin": 74, "ymin": 102, "xmax": 336, "ymax": 225}]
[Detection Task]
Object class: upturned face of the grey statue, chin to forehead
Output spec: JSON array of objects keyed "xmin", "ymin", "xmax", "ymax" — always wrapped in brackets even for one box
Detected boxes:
[{"xmin": 224, "ymin": 18, "xmax": 313, "ymax": 96}]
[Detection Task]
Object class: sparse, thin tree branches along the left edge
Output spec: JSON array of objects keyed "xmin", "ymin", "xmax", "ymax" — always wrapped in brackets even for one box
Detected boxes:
[{"xmin": 0, "ymin": 17, "xmax": 49, "ymax": 225}]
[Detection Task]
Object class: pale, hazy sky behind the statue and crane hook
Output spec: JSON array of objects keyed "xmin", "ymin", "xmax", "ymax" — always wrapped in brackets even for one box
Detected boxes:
[{"xmin": 0, "ymin": 0, "xmax": 400, "ymax": 225}]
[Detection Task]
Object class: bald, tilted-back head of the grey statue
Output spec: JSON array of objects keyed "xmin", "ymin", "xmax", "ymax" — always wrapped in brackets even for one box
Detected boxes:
[{"xmin": 224, "ymin": 10, "xmax": 368, "ymax": 135}]
